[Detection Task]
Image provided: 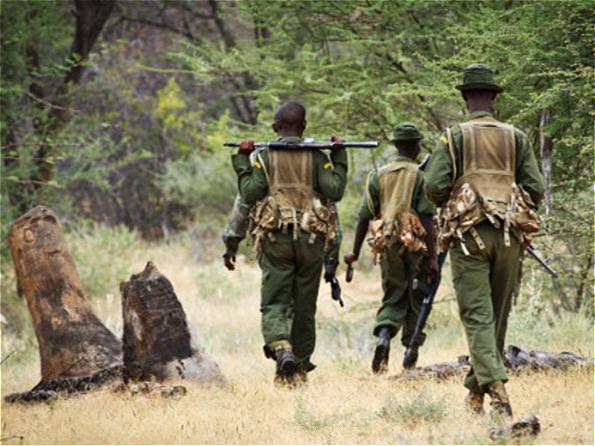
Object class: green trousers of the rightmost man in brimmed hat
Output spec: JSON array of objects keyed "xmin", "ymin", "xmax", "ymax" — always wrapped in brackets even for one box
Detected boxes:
[{"xmin": 449, "ymin": 221, "xmax": 522, "ymax": 393}]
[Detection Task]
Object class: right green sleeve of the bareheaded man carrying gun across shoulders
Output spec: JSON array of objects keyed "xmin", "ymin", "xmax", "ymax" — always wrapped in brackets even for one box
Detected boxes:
[{"xmin": 314, "ymin": 149, "xmax": 347, "ymax": 202}]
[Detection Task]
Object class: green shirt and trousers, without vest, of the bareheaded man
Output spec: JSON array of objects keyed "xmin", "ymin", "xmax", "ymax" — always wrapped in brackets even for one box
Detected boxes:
[{"xmin": 232, "ymin": 138, "xmax": 347, "ymax": 370}]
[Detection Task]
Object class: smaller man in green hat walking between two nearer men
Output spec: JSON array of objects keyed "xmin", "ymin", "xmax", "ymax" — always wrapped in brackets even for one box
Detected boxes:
[{"xmin": 345, "ymin": 123, "xmax": 438, "ymax": 373}]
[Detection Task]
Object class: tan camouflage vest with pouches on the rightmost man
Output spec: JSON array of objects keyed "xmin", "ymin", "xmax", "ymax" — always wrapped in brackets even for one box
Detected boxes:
[{"xmin": 438, "ymin": 117, "xmax": 539, "ymax": 254}]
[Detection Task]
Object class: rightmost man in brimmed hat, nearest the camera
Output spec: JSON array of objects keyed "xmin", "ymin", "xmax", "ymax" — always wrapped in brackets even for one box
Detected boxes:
[{"xmin": 425, "ymin": 64, "xmax": 544, "ymax": 416}]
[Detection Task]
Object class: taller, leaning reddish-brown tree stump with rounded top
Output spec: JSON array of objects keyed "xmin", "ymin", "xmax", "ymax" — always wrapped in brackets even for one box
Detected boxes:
[{"xmin": 8, "ymin": 206, "xmax": 122, "ymax": 390}]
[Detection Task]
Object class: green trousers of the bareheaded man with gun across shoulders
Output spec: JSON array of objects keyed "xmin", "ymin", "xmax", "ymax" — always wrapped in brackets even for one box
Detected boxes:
[{"xmin": 259, "ymin": 230, "xmax": 323, "ymax": 368}]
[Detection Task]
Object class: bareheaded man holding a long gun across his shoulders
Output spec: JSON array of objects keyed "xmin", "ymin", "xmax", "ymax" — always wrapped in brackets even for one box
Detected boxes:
[{"xmin": 232, "ymin": 102, "xmax": 347, "ymax": 381}]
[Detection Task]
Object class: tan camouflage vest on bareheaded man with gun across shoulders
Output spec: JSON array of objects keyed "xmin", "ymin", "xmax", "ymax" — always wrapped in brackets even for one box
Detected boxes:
[{"xmin": 252, "ymin": 150, "xmax": 338, "ymax": 250}]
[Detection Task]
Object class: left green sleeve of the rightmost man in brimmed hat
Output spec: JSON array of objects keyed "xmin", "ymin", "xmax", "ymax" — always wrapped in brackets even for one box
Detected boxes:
[{"xmin": 423, "ymin": 133, "xmax": 453, "ymax": 206}]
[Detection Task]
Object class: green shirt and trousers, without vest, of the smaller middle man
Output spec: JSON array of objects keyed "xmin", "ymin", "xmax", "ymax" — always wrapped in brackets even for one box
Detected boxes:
[{"xmin": 359, "ymin": 156, "xmax": 436, "ymax": 346}]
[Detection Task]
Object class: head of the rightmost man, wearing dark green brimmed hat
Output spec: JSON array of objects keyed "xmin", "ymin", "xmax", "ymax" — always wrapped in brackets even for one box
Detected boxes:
[{"xmin": 456, "ymin": 64, "xmax": 503, "ymax": 112}]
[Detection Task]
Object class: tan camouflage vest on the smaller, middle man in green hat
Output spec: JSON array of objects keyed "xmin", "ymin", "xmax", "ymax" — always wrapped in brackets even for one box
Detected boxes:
[{"xmin": 366, "ymin": 161, "xmax": 427, "ymax": 262}]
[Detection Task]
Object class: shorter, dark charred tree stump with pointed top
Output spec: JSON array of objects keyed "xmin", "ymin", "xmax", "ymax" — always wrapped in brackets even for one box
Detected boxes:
[{"xmin": 120, "ymin": 262, "xmax": 225, "ymax": 382}]
